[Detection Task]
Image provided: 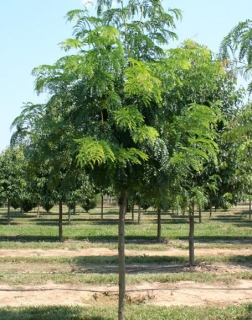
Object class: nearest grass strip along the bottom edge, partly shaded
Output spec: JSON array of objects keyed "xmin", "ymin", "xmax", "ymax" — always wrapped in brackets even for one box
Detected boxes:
[{"xmin": 0, "ymin": 304, "xmax": 252, "ymax": 320}]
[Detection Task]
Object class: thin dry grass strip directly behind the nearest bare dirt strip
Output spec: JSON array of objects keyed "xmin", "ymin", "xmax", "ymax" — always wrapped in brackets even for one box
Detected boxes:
[{"xmin": 0, "ymin": 270, "xmax": 252, "ymax": 286}]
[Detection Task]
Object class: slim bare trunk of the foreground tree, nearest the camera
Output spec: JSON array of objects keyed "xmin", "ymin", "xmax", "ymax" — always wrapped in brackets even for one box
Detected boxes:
[{"xmin": 118, "ymin": 191, "xmax": 127, "ymax": 320}]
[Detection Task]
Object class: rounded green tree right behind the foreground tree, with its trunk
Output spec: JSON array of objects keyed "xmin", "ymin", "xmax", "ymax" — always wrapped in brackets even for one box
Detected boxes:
[{"xmin": 158, "ymin": 40, "xmax": 241, "ymax": 264}]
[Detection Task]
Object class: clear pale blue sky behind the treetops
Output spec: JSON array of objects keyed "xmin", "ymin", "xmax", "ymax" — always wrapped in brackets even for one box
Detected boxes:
[{"xmin": 0, "ymin": 0, "xmax": 252, "ymax": 151}]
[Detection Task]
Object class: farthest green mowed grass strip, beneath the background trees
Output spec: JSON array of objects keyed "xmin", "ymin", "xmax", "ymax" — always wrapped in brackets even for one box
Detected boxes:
[{"xmin": 0, "ymin": 209, "xmax": 252, "ymax": 246}]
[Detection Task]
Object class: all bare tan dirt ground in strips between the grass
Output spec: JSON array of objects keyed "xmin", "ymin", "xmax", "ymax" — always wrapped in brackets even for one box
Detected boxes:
[{"xmin": 0, "ymin": 248, "xmax": 252, "ymax": 307}]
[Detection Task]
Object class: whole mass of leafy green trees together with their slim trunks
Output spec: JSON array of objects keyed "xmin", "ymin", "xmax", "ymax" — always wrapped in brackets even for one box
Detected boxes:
[{"xmin": 0, "ymin": 0, "xmax": 252, "ymax": 319}]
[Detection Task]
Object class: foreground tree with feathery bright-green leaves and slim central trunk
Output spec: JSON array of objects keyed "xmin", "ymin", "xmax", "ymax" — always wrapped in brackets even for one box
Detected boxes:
[{"xmin": 10, "ymin": 0, "xmax": 181, "ymax": 319}]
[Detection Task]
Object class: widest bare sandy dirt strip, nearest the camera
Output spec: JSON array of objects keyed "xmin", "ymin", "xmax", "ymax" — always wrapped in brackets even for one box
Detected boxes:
[{"xmin": 0, "ymin": 280, "xmax": 252, "ymax": 307}]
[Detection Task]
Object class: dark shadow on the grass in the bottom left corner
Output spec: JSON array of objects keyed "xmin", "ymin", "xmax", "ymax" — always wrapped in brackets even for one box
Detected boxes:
[{"xmin": 0, "ymin": 306, "xmax": 109, "ymax": 320}]
